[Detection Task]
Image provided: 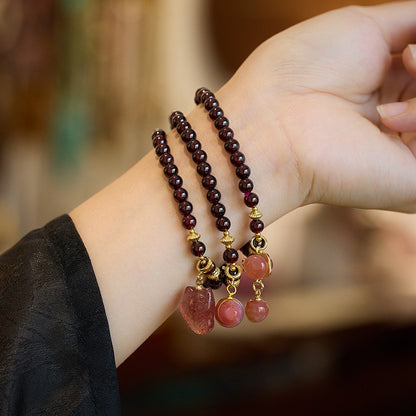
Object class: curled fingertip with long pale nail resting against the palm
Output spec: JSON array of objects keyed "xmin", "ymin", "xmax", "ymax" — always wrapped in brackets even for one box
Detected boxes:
[{"xmin": 377, "ymin": 98, "xmax": 416, "ymax": 132}]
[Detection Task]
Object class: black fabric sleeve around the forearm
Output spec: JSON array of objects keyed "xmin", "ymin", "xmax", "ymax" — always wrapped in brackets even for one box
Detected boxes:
[{"xmin": 0, "ymin": 215, "xmax": 120, "ymax": 416}]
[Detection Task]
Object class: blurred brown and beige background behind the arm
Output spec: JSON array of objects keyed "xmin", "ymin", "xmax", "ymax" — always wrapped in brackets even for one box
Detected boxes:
[{"xmin": 0, "ymin": 0, "xmax": 416, "ymax": 416}]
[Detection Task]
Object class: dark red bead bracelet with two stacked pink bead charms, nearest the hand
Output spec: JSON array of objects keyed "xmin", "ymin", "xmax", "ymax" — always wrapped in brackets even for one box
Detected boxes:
[{"xmin": 195, "ymin": 88, "xmax": 273, "ymax": 322}]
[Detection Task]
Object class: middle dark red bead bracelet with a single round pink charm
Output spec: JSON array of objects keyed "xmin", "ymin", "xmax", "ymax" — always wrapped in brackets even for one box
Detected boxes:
[{"xmin": 169, "ymin": 111, "xmax": 244, "ymax": 328}]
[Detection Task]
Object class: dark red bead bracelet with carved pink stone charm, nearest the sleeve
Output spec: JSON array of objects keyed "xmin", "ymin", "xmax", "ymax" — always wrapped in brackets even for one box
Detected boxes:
[{"xmin": 152, "ymin": 130, "xmax": 220, "ymax": 335}]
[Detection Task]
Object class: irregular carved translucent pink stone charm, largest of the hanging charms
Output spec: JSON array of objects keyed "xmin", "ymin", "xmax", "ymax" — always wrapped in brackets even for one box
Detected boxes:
[{"xmin": 179, "ymin": 286, "xmax": 215, "ymax": 335}]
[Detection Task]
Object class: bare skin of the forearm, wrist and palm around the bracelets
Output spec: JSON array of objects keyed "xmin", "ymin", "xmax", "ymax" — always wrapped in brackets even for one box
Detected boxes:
[{"xmin": 70, "ymin": 1, "xmax": 416, "ymax": 365}]
